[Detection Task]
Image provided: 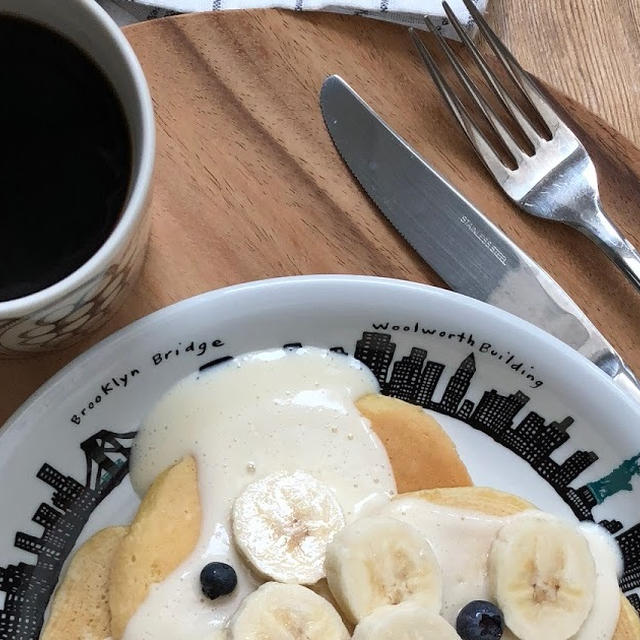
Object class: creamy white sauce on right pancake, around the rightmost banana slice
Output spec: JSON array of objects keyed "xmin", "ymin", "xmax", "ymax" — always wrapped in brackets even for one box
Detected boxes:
[{"xmin": 380, "ymin": 496, "xmax": 621, "ymax": 640}]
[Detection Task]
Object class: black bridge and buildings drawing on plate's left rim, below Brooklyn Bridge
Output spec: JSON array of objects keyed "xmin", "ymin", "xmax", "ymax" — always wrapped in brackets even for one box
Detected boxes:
[{"xmin": 0, "ymin": 430, "xmax": 135, "ymax": 640}]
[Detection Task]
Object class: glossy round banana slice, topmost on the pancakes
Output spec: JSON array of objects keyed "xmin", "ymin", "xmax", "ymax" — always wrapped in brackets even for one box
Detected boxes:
[{"xmin": 232, "ymin": 471, "xmax": 344, "ymax": 584}]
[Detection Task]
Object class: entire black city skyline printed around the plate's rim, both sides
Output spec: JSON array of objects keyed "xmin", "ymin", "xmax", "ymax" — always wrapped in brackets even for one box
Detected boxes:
[{"xmin": 0, "ymin": 331, "xmax": 640, "ymax": 640}]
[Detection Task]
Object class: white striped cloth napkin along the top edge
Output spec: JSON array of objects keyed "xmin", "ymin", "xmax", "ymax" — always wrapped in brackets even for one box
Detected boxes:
[{"xmin": 97, "ymin": 0, "xmax": 487, "ymax": 36}]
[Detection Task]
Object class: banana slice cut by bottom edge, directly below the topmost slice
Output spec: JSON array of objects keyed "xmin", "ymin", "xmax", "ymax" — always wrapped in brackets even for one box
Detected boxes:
[{"xmin": 229, "ymin": 582, "xmax": 349, "ymax": 640}]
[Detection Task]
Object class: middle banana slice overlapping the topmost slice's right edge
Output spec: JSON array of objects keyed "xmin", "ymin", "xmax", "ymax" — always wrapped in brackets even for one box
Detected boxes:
[{"xmin": 325, "ymin": 516, "xmax": 442, "ymax": 622}]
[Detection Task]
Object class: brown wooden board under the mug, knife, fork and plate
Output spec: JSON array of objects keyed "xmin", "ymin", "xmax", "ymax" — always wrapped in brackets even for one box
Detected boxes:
[{"xmin": 0, "ymin": 11, "xmax": 640, "ymax": 424}]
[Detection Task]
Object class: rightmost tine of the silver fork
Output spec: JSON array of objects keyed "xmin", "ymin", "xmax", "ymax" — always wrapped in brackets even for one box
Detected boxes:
[{"xmin": 458, "ymin": 0, "xmax": 563, "ymax": 135}]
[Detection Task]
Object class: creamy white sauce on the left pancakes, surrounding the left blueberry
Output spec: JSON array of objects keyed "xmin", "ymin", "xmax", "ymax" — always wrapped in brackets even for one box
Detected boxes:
[{"xmin": 124, "ymin": 348, "xmax": 396, "ymax": 640}]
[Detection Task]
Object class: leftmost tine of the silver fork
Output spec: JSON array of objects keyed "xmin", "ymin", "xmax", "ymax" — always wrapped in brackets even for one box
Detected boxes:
[{"xmin": 409, "ymin": 28, "xmax": 513, "ymax": 183}]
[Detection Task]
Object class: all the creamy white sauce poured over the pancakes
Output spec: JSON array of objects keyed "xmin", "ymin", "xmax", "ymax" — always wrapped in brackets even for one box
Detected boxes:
[{"xmin": 124, "ymin": 348, "xmax": 621, "ymax": 640}]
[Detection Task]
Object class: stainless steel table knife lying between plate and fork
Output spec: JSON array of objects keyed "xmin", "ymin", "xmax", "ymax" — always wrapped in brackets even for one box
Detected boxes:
[{"xmin": 320, "ymin": 76, "xmax": 640, "ymax": 402}]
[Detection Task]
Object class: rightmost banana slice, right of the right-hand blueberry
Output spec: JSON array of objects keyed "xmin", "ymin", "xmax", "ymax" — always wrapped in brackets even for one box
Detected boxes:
[{"xmin": 489, "ymin": 514, "xmax": 596, "ymax": 640}]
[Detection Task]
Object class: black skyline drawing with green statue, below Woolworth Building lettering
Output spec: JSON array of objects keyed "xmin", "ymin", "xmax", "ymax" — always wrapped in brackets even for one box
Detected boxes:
[{"xmin": 354, "ymin": 331, "xmax": 640, "ymax": 613}]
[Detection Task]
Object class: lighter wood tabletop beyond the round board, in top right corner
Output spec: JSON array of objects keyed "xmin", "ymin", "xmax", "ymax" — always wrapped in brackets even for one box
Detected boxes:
[{"xmin": 488, "ymin": 0, "xmax": 640, "ymax": 145}]
